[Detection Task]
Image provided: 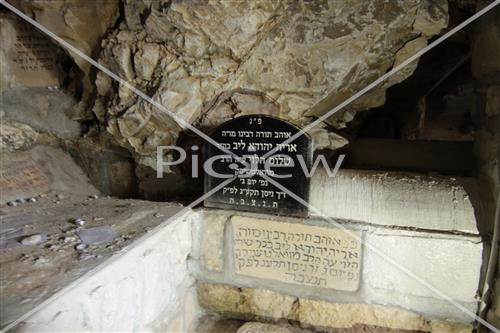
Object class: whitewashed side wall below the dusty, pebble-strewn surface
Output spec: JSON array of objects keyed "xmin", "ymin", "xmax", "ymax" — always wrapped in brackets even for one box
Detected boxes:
[{"xmin": 3, "ymin": 210, "xmax": 199, "ymax": 332}]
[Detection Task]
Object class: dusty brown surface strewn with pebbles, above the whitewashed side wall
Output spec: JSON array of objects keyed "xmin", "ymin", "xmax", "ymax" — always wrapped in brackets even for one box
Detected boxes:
[{"xmin": 0, "ymin": 193, "xmax": 182, "ymax": 327}]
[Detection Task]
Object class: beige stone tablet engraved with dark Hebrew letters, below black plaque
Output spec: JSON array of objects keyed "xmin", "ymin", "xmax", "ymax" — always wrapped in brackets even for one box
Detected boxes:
[{"xmin": 232, "ymin": 216, "xmax": 361, "ymax": 291}]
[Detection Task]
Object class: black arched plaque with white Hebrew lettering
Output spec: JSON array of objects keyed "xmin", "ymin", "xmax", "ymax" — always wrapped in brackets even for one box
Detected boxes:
[{"xmin": 204, "ymin": 115, "xmax": 312, "ymax": 216}]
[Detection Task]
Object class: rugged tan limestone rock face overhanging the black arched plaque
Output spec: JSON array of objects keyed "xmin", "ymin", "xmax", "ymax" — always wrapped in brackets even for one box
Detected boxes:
[{"xmin": 94, "ymin": 0, "xmax": 448, "ymax": 163}]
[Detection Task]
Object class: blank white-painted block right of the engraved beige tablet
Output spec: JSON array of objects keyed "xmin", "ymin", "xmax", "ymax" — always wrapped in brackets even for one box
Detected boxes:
[{"xmin": 363, "ymin": 230, "xmax": 483, "ymax": 302}]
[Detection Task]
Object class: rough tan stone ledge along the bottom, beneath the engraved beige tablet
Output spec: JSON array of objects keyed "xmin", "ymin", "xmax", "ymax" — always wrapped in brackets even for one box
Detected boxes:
[{"xmin": 198, "ymin": 282, "xmax": 472, "ymax": 333}]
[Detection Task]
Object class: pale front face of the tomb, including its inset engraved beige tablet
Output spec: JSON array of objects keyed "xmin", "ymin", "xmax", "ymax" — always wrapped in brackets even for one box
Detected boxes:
[{"xmin": 199, "ymin": 211, "xmax": 483, "ymax": 323}]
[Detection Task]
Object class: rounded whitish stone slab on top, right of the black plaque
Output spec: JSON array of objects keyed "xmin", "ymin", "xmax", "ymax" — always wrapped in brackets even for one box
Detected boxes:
[{"xmin": 309, "ymin": 170, "xmax": 479, "ymax": 234}]
